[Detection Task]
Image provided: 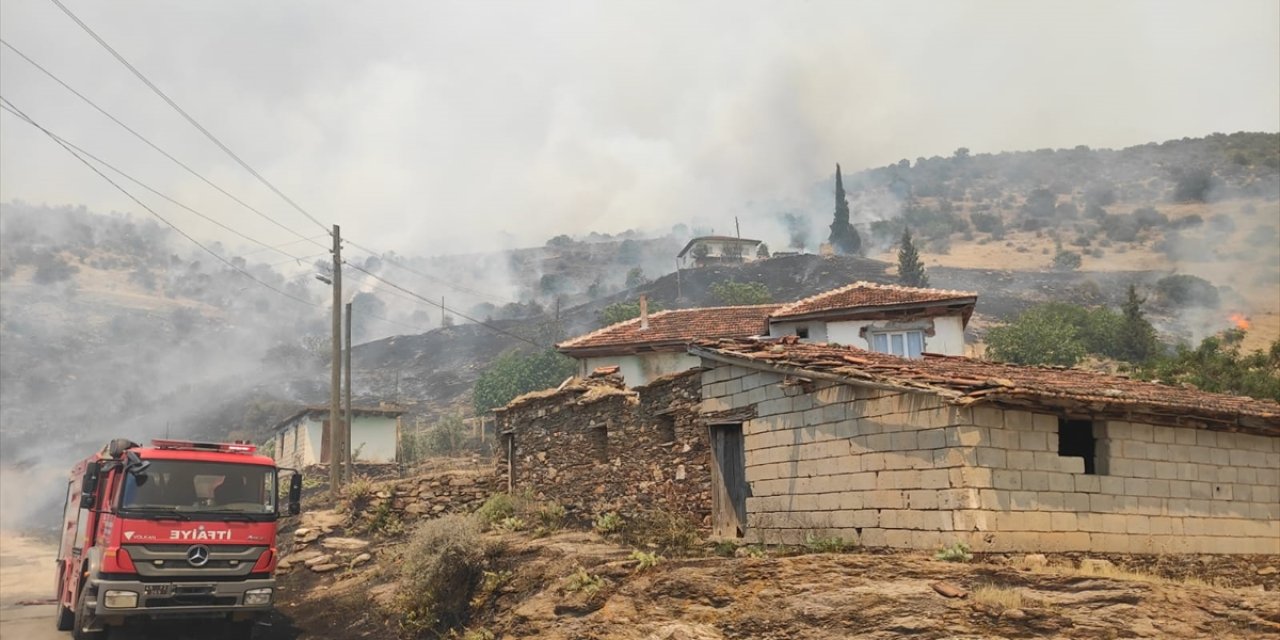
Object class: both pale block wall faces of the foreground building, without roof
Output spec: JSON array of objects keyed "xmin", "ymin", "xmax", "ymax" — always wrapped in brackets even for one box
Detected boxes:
[{"xmin": 703, "ymin": 362, "xmax": 1280, "ymax": 554}]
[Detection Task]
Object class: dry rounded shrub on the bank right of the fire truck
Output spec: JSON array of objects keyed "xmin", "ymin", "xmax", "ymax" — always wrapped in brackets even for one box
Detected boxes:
[{"xmin": 397, "ymin": 515, "xmax": 494, "ymax": 634}]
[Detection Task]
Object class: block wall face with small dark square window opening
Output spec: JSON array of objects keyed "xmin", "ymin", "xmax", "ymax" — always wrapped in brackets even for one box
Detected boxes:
[{"xmin": 952, "ymin": 407, "xmax": 1280, "ymax": 554}]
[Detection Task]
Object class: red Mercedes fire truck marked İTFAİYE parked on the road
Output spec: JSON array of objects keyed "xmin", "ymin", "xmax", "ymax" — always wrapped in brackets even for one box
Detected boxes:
[{"xmin": 58, "ymin": 439, "xmax": 302, "ymax": 640}]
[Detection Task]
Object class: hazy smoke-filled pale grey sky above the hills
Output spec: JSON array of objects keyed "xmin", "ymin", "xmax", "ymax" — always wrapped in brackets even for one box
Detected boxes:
[{"xmin": 0, "ymin": 0, "xmax": 1280, "ymax": 253}]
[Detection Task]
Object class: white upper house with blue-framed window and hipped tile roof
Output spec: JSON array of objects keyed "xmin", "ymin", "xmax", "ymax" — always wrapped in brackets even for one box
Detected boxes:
[{"xmin": 769, "ymin": 282, "xmax": 978, "ymax": 358}]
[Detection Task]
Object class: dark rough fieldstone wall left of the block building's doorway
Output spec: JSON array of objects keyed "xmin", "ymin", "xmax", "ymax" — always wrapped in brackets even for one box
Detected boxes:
[{"xmin": 495, "ymin": 371, "xmax": 710, "ymax": 526}]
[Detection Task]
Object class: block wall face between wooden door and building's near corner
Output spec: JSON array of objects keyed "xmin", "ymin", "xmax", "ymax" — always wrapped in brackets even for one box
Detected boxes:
[{"xmin": 703, "ymin": 365, "xmax": 978, "ymax": 548}]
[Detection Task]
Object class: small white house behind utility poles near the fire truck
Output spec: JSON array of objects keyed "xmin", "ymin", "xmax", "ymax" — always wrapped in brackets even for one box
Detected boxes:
[{"xmin": 271, "ymin": 406, "xmax": 404, "ymax": 468}]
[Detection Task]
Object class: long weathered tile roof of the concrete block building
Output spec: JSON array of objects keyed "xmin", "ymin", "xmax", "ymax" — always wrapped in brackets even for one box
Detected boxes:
[{"xmin": 690, "ymin": 337, "xmax": 1280, "ymax": 435}]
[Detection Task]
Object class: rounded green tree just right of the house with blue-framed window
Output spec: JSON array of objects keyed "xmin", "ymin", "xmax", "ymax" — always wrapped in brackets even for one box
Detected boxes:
[{"xmin": 987, "ymin": 305, "xmax": 1085, "ymax": 366}]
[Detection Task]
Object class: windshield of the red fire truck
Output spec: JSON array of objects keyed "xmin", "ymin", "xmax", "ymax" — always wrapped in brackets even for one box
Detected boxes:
[{"xmin": 120, "ymin": 460, "xmax": 276, "ymax": 520}]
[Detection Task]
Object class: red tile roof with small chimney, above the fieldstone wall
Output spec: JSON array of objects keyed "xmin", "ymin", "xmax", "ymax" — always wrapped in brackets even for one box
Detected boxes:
[{"xmin": 556, "ymin": 305, "xmax": 782, "ymax": 352}]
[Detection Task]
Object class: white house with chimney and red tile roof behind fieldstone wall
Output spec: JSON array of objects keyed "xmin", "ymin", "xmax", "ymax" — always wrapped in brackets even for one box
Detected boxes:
[{"xmin": 556, "ymin": 301, "xmax": 782, "ymax": 387}]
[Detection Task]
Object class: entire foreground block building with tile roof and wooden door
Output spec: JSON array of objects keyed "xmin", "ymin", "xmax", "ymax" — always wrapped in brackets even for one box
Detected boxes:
[{"xmin": 690, "ymin": 337, "xmax": 1280, "ymax": 554}]
